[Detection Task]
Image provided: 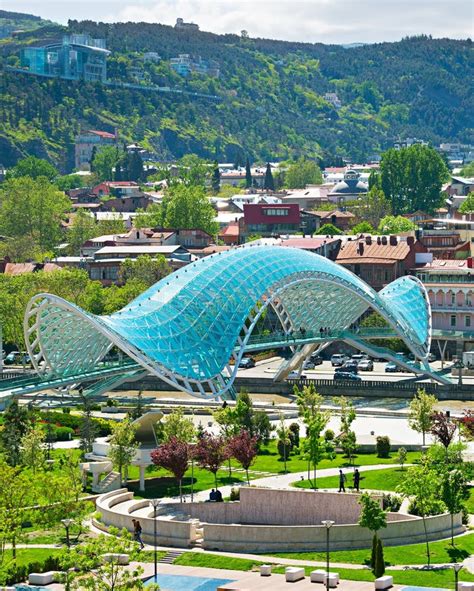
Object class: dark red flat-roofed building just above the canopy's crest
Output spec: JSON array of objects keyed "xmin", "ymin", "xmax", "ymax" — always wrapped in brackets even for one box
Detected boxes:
[{"xmin": 244, "ymin": 203, "xmax": 301, "ymax": 236}]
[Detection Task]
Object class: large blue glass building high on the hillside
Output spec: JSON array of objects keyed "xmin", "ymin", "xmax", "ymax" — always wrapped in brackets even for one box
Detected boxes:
[{"xmin": 20, "ymin": 34, "xmax": 110, "ymax": 82}]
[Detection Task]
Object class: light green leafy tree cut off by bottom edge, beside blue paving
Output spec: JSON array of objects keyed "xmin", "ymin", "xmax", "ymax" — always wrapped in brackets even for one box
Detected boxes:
[{"xmin": 60, "ymin": 527, "xmax": 158, "ymax": 591}]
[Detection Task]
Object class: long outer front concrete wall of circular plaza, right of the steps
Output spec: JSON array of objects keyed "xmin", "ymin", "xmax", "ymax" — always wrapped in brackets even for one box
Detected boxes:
[{"xmin": 203, "ymin": 514, "xmax": 465, "ymax": 553}]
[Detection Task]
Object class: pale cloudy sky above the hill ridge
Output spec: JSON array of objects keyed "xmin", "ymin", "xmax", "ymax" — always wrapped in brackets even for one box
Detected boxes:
[{"xmin": 4, "ymin": 0, "xmax": 474, "ymax": 43}]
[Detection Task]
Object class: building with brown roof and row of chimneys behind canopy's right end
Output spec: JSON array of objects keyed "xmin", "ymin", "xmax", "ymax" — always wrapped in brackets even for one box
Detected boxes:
[{"xmin": 336, "ymin": 236, "xmax": 427, "ymax": 290}]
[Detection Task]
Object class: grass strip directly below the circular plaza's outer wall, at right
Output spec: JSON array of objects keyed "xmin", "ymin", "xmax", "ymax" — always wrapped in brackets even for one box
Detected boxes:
[{"xmin": 274, "ymin": 533, "xmax": 474, "ymax": 566}]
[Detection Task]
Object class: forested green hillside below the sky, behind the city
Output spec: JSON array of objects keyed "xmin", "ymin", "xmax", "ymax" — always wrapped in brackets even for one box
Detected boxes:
[{"xmin": 0, "ymin": 15, "xmax": 474, "ymax": 170}]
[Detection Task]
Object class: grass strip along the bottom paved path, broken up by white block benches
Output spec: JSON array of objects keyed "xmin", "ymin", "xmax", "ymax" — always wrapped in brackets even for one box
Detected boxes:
[{"xmin": 174, "ymin": 552, "xmax": 473, "ymax": 589}]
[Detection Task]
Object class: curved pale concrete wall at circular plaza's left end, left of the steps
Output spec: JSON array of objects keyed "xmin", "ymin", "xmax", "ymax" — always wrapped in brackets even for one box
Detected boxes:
[{"xmin": 96, "ymin": 489, "xmax": 196, "ymax": 548}]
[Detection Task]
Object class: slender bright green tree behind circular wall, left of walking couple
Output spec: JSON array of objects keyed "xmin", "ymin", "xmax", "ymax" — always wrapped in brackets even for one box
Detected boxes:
[{"xmin": 294, "ymin": 384, "xmax": 333, "ymax": 489}]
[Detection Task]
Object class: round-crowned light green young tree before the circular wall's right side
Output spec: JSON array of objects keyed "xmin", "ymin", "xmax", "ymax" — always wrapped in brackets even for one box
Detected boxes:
[{"xmin": 397, "ymin": 465, "xmax": 440, "ymax": 566}]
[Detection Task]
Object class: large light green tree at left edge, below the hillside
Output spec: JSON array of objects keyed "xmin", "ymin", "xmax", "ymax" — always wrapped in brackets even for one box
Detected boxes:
[{"xmin": 0, "ymin": 177, "xmax": 71, "ymax": 252}]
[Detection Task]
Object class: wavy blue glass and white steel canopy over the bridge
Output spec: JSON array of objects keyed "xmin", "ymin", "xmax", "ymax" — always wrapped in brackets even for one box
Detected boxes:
[{"xmin": 25, "ymin": 245, "xmax": 431, "ymax": 396}]
